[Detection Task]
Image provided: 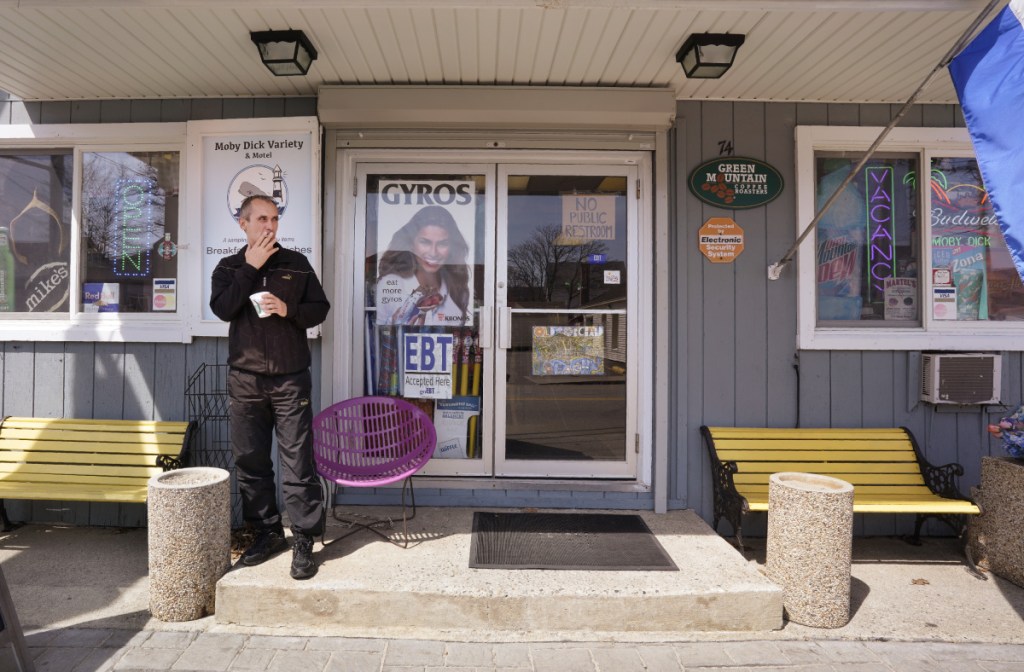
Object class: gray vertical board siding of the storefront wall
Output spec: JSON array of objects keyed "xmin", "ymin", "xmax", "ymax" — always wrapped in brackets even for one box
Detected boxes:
[{"xmin": 0, "ymin": 98, "xmax": 1011, "ymax": 534}]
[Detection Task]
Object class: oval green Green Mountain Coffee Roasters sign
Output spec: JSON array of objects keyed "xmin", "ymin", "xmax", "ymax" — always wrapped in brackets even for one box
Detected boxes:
[{"xmin": 689, "ymin": 157, "xmax": 782, "ymax": 210}]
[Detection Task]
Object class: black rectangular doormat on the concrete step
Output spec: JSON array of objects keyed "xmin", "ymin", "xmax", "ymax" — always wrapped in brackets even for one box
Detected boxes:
[{"xmin": 469, "ymin": 511, "xmax": 679, "ymax": 572}]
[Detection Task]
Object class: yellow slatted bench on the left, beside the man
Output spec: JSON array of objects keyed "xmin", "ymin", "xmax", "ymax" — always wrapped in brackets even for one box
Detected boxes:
[{"xmin": 0, "ymin": 417, "xmax": 196, "ymax": 530}]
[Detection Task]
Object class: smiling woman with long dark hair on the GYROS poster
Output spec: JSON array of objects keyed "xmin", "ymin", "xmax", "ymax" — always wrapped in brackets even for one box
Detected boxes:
[{"xmin": 377, "ymin": 205, "xmax": 470, "ymax": 327}]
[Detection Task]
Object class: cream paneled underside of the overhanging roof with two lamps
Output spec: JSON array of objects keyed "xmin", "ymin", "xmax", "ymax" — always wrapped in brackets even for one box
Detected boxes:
[{"xmin": 0, "ymin": 0, "xmax": 1003, "ymax": 103}]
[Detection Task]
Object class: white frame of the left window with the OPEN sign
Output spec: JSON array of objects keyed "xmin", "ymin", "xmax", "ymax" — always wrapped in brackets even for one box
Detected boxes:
[{"xmin": 0, "ymin": 122, "xmax": 188, "ymax": 343}]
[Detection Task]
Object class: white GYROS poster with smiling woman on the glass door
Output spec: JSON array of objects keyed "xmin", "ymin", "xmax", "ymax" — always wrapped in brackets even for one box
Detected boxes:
[{"xmin": 376, "ymin": 180, "xmax": 476, "ymax": 327}]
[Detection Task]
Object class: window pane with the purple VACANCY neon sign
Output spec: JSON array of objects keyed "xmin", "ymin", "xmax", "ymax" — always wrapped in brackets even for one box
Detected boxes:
[{"xmin": 815, "ymin": 153, "xmax": 920, "ymax": 326}]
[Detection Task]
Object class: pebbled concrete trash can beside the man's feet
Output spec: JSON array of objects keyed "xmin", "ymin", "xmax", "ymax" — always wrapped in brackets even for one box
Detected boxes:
[{"xmin": 146, "ymin": 467, "xmax": 231, "ymax": 621}]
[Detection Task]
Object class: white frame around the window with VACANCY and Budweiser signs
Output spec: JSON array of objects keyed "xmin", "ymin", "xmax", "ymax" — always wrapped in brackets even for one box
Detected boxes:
[{"xmin": 796, "ymin": 126, "xmax": 1024, "ymax": 351}]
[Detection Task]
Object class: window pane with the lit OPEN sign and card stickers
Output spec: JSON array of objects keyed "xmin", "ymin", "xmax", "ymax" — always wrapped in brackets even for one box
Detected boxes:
[{"xmin": 82, "ymin": 152, "xmax": 179, "ymax": 312}]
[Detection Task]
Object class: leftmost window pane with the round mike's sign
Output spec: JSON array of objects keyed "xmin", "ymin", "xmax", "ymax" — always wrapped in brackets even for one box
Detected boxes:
[{"xmin": 0, "ymin": 150, "xmax": 74, "ymax": 313}]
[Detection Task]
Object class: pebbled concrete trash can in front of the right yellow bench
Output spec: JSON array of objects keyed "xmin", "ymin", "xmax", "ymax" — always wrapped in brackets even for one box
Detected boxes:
[{"xmin": 766, "ymin": 471, "xmax": 853, "ymax": 628}]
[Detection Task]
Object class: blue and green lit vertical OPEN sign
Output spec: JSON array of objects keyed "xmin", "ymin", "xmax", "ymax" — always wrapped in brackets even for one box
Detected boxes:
[{"xmin": 114, "ymin": 177, "xmax": 157, "ymax": 278}]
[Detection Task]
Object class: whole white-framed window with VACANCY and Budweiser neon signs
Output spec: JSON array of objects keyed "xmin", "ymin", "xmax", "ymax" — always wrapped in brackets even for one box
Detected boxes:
[{"xmin": 797, "ymin": 126, "xmax": 1024, "ymax": 351}]
